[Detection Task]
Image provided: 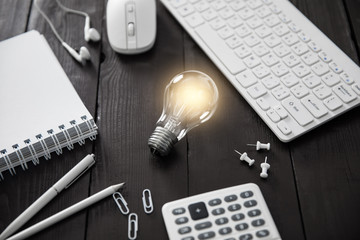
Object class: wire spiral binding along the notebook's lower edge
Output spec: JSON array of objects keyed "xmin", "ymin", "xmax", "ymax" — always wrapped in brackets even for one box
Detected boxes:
[{"xmin": 0, "ymin": 116, "xmax": 97, "ymax": 180}]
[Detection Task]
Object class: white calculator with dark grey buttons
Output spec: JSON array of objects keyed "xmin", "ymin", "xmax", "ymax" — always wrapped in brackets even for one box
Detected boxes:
[{"xmin": 162, "ymin": 183, "xmax": 281, "ymax": 240}]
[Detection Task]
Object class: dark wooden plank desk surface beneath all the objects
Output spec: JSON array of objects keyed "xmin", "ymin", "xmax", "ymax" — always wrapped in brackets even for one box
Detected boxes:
[{"xmin": 0, "ymin": 0, "xmax": 360, "ymax": 240}]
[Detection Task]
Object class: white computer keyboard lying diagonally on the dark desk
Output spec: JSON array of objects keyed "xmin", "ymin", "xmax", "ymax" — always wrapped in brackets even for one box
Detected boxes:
[{"xmin": 161, "ymin": 0, "xmax": 360, "ymax": 142}]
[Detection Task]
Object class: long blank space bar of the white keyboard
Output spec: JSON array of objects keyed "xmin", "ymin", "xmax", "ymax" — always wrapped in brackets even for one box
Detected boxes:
[{"xmin": 195, "ymin": 25, "xmax": 245, "ymax": 75}]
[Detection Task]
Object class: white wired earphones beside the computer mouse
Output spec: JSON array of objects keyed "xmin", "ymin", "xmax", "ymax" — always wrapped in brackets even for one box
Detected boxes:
[{"xmin": 34, "ymin": 0, "xmax": 101, "ymax": 64}]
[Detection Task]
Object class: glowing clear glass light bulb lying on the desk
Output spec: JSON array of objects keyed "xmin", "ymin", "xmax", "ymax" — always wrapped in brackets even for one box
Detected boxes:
[{"xmin": 148, "ymin": 71, "xmax": 219, "ymax": 156}]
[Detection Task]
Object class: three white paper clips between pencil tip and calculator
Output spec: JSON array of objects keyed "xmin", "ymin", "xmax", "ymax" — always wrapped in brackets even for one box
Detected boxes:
[{"xmin": 113, "ymin": 189, "xmax": 154, "ymax": 240}]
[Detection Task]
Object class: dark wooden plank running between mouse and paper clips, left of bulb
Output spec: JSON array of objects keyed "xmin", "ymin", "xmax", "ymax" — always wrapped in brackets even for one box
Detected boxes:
[{"xmin": 86, "ymin": 0, "xmax": 187, "ymax": 240}]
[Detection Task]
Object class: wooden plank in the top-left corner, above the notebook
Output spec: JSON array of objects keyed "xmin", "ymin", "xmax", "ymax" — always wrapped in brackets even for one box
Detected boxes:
[{"xmin": 0, "ymin": 0, "xmax": 31, "ymax": 41}]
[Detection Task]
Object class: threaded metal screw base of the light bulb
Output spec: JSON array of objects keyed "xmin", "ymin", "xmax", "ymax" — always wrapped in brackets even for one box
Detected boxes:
[{"xmin": 148, "ymin": 126, "xmax": 178, "ymax": 156}]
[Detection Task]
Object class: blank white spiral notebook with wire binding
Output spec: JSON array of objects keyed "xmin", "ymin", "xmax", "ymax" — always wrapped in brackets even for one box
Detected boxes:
[{"xmin": 0, "ymin": 30, "xmax": 97, "ymax": 179}]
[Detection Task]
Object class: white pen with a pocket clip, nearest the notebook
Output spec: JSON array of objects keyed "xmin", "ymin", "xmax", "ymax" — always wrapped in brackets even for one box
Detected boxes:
[{"xmin": 0, "ymin": 154, "xmax": 95, "ymax": 240}]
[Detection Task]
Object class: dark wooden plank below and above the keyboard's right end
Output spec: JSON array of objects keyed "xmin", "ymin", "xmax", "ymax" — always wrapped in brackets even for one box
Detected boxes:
[{"xmin": 290, "ymin": 0, "xmax": 360, "ymax": 240}]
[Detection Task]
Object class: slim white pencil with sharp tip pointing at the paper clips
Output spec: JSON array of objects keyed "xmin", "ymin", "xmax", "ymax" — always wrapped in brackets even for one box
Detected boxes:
[{"xmin": 7, "ymin": 183, "xmax": 125, "ymax": 240}]
